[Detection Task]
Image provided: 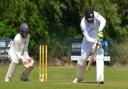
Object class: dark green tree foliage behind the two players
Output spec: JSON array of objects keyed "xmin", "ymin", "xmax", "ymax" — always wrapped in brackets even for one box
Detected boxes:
[{"xmin": 0, "ymin": 0, "xmax": 128, "ymax": 63}]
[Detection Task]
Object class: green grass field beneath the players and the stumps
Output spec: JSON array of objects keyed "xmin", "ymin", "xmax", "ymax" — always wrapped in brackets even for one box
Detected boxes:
[{"xmin": 0, "ymin": 65, "xmax": 128, "ymax": 89}]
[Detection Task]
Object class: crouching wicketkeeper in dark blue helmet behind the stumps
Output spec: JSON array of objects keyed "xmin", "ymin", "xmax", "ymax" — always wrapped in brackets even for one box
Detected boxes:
[{"xmin": 5, "ymin": 23, "xmax": 34, "ymax": 82}]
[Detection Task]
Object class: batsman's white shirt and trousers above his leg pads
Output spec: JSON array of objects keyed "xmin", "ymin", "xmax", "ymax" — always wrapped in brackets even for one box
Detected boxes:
[{"xmin": 80, "ymin": 11, "xmax": 106, "ymax": 60}]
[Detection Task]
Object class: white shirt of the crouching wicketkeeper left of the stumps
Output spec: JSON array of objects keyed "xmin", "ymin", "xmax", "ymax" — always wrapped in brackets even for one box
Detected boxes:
[{"xmin": 8, "ymin": 33, "xmax": 30, "ymax": 63}]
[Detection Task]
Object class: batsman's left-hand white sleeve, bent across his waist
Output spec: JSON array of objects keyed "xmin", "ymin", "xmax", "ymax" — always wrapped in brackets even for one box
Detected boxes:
[{"xmin": 80, "ymin": 18, "xmax": 96, "ymax": 43}]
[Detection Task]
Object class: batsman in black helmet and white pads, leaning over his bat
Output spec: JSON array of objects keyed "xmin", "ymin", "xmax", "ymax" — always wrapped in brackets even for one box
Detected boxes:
[{"xmin": 73, "ymin": 8, "xmax": 106, "ymax": 84}]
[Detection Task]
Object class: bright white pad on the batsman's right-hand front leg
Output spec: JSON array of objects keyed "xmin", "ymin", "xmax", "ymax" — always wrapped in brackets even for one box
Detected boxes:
[{"xmin": 96, "ymin": 48, "xmax": 104, "ymax": 82}]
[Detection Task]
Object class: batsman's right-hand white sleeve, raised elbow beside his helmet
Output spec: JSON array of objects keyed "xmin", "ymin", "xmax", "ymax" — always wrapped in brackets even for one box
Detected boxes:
[{"xmin": 94, "ymin": 11, "xmax": 106, "ymax": 31}]
